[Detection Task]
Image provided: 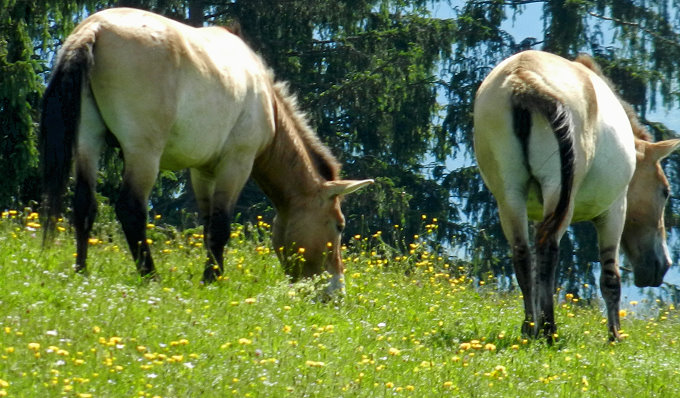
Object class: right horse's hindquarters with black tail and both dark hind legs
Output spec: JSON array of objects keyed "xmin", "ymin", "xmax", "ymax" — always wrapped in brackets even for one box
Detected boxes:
[{"xmin": 474, "ymin": 69, "xmax": 574, "ymax": 340}]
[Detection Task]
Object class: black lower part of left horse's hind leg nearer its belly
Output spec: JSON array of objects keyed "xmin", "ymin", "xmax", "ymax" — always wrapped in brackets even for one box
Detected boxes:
[{"xmin": 116, "ymin": 181, "xmax": 156, "ymax": 276}]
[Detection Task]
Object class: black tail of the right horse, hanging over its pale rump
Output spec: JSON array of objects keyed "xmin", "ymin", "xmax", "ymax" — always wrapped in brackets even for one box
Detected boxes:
[{"xmin": 513, "ymin": 92, "xmax": 574, "ymax": 242}]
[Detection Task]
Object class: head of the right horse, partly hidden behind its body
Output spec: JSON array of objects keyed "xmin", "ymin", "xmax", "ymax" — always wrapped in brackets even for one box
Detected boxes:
[{"xmin": 621, "ymin": 139, "xmax": 680, "ymax": 287}]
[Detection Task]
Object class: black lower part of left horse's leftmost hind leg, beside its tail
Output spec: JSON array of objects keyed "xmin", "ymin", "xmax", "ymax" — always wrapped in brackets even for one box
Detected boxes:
[{"xmin": 73, "ymin": 168, "xmax": 97, "ymax": 272}]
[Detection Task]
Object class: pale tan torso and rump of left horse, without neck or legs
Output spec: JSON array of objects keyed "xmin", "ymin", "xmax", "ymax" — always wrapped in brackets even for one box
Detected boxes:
[{"xmin": 67, "ymin": 8, "xmax": 273, "ymax": 169}]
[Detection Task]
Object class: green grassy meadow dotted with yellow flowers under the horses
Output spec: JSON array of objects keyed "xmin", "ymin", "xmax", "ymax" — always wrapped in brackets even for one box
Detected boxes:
[{"xmin": 0, "ymin": 213, "xmax": 680, "ymax": 397}]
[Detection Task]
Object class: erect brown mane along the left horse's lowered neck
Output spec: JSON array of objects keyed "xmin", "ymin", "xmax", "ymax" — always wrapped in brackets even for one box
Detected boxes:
[{"xmin": 273, "ymin": 82, "xmax": 340, "ymax": 181}]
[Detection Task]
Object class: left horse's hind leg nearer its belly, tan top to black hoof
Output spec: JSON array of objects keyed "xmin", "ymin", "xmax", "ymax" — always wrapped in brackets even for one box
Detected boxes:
[{"xmin": 116, "ymin": 149, "xmax": 159, "ymax": 277}]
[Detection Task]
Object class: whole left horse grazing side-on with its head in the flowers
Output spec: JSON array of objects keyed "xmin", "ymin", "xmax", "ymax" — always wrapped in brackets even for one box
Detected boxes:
[{"xmin": 40, "ymin": 8, "xmax": 373, "ymax": 291}]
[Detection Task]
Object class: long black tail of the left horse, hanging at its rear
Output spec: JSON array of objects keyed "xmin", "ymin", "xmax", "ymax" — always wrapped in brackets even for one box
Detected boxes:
[{"xmin": 39, "ymin": 44, "xmax": 93, "ymax": 238}]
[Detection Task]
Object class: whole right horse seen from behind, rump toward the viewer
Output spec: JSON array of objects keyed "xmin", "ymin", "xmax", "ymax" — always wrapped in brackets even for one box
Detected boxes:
[{"xmin": 474, "ymin": 51, "xmax": 680, "ymax": 341}]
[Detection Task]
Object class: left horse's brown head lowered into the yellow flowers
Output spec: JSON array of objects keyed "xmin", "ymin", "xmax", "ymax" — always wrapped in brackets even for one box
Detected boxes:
[{"xmin": 272, "ymin": 180, "xmax": 373, "ymax": 293}]
